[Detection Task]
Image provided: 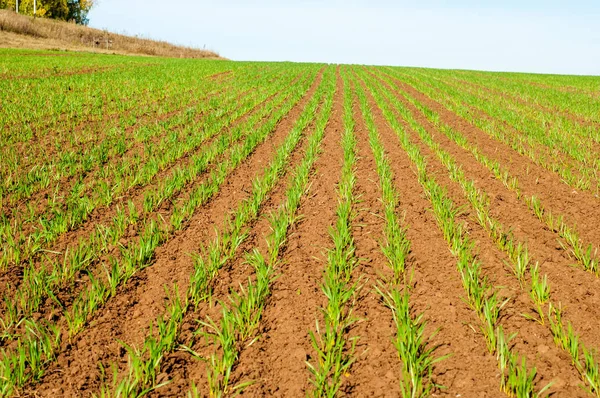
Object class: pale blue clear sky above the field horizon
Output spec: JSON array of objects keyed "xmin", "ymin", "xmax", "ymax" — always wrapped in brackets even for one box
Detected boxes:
[{"xmin": 88, "ymin": 0, "xmax": 600, "ymax": 75}]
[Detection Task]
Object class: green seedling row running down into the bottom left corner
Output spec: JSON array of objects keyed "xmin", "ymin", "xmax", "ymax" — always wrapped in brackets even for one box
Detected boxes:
[{"xmin": 0, "ymin": 67, "xmax": 324, "ymax": 392}]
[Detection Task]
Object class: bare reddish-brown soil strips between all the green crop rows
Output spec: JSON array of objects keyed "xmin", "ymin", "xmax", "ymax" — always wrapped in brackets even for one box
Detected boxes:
[{"xmin": 5, "ymin": 60, "xmax": 600, "ymax": 397}]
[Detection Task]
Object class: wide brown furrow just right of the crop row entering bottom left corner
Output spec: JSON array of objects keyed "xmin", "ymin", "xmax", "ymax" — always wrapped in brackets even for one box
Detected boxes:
[{"xmin": 23, "ymin": 69, "xmax": 320, "ymax": 396}]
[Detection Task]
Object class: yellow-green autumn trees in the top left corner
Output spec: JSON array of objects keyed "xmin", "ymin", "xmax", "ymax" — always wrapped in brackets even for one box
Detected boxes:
[{"xmin": 0, "ymin": 0, "xmax": 95, "ymax": 25}]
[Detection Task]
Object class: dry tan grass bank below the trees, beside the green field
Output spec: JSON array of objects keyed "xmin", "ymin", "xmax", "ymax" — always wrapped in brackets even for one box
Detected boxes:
[{"xmin": 0, "ymin": 10, "xmax": 221, "ymax": 59}]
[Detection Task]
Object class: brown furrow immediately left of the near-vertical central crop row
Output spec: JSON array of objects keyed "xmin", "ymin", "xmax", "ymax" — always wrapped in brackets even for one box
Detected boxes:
[{"xmin": 212, "ymin": 67, "xmax": 343, "ymax": 397}]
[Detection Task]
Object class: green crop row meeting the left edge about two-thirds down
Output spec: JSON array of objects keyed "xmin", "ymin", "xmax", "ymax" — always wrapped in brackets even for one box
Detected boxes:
[{"xmin": 0, "ymin": 63, "xmax": 300, "ymax": 272}]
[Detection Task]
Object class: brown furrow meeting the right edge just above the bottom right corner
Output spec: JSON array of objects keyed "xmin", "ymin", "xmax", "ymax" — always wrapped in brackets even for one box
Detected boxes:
[{"xmin": 384, "ymin": 71, "xmax": 600, "ymax": 364}]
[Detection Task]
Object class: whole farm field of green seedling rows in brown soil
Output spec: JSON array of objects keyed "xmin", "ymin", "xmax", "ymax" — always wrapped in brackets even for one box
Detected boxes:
[{"xmin": 0, "ymin": 49, "xmax": 600, "ymax": 397}]
